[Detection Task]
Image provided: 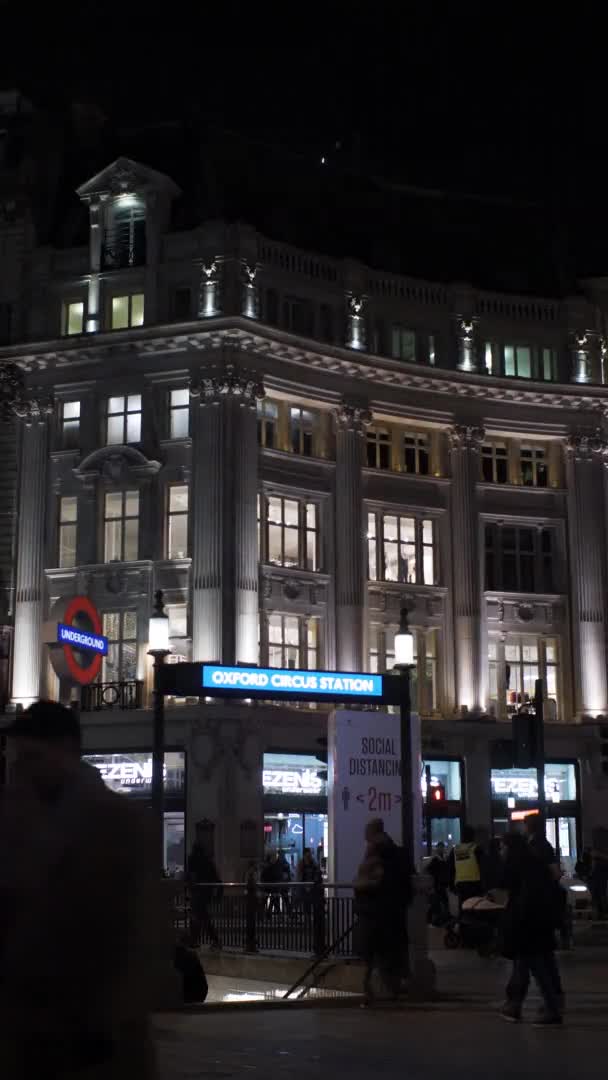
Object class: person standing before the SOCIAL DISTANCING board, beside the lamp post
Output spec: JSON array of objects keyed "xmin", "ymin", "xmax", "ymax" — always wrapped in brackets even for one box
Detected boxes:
[{"xmin": 354, "ymin": 818, "xmax": 411, "ymax": 1005}]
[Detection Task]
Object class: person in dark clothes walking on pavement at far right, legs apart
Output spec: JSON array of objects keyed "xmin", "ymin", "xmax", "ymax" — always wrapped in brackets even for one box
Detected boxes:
[{"xmin": 501, "ymin": 833, "xmax": 563, "ymax": 1027}]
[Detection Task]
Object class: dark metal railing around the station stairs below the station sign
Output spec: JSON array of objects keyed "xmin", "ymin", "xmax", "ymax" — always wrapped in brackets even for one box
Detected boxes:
[{"xmin": 174, "ymin": 881, "xmax": 356, "ymax": 957}]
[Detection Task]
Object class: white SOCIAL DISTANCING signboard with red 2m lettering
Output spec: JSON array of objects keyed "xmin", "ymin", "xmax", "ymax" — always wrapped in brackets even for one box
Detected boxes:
[{"xmin": 328, "ymin": 710, "xmax": 422, "ymax": 883}]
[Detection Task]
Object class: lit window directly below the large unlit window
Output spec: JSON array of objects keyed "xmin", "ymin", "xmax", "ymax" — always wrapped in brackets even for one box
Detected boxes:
[{"xmin": 488, "ymin": 634, "xmax": 560, "ymax": 720}]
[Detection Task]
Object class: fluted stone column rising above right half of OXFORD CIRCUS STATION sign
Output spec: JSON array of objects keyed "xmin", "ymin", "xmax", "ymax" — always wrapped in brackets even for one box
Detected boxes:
[{"xmin": 335, "ymin": 404, "xmax": 371, "ymax": 672}]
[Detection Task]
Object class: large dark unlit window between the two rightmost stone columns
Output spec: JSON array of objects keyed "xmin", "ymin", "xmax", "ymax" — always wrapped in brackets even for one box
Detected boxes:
[{"xmin": 485, "ymin": 524, "xmax": 555, "ymax": 593}]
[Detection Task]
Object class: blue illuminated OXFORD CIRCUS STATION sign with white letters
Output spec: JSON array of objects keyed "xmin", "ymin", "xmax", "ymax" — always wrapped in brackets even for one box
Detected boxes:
[{"xmin": 202, "ymin": 664, "xmax": 383, "ymax": 701}]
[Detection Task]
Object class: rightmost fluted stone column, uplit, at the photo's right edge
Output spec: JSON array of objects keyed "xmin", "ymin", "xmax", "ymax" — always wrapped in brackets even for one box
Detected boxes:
[{"xmin": 566, "ymin": 434, "xmax": 608, "ymax": 719}]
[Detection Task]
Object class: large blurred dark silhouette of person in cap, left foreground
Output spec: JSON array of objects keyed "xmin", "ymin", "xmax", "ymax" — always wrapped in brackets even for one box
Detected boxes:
[{"xmin": 0, "ymin": 701, "xmax": 174, "ymax": 1080}]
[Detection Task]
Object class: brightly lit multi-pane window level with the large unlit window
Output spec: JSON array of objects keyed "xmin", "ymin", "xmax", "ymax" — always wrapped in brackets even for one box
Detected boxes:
[{"xmin": 367, "ymin": 512, "xmax": 437, "ymax": 585}]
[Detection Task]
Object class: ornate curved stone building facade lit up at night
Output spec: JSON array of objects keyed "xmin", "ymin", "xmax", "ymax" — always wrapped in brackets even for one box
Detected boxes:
[{"xmin": 0, "ymin": 150, "xmax": 608, "ymax": 878}]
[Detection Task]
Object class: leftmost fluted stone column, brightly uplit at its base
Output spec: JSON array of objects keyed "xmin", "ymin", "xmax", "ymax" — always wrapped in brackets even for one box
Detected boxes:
[{"xmin": 13, "ymin": 393, "xmax": 53, "ymax": 707}]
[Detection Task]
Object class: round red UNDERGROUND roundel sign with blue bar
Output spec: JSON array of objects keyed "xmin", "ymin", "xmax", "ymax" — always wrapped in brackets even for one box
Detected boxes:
[{"xmin": 46, "ymin": 596, "xmax": 108, "ymax": 686}]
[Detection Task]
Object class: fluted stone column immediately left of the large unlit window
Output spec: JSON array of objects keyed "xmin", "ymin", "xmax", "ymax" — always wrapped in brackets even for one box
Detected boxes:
[{"xmin": 448, "ymin": 424, "xmax": 484, "ymax": 712}]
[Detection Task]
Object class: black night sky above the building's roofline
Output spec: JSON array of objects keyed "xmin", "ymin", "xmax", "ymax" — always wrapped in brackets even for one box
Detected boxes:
[{"xmin": 0, "ymin": 0, "xmax": 608, "ymax": 282}]
